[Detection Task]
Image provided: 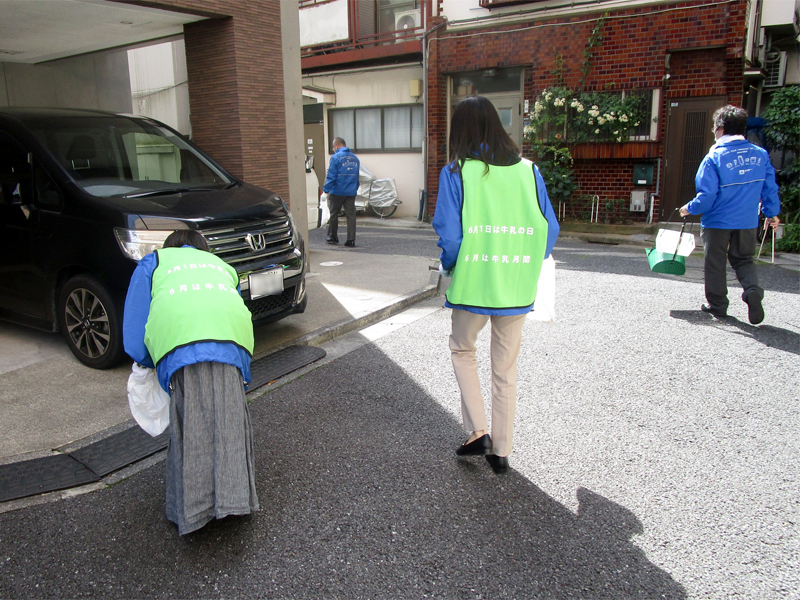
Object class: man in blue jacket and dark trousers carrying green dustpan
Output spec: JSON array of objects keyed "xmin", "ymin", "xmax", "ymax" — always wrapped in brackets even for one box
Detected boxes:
[{"xmin": 680, "ymin": 105, "xmax": 781, "ymax": 325}]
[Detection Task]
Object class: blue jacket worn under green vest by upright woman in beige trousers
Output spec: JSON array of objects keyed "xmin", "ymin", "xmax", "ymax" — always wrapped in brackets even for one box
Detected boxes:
[{"xmin": 433, "ymin": 159, "xmax": 561, "ymax": 315}]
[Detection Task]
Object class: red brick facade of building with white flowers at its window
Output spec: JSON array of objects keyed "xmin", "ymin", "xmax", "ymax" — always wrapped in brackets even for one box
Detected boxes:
[{"xmin": 428, "ymin": 0, "xmax": 746, "ymax": 220}]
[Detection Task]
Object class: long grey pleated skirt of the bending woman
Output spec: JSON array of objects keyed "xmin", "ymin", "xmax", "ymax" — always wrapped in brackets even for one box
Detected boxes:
[{"xmin": 166, "ymin": 362, "xmax": 259, "ymax": 535}]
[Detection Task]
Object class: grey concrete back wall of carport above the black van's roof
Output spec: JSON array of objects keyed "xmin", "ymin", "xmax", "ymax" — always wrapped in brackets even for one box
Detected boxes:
[{"xmin": 0, "ymin": 51, "xmax": 131, "ymax": 113}]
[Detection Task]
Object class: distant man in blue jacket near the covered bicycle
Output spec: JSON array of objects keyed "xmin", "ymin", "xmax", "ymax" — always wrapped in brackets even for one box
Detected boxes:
[{"xmin": 322, "ymin": 138, "xmax": 361, "ymax": 248}]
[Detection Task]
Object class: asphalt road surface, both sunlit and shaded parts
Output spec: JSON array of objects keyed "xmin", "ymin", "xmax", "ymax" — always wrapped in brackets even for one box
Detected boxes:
[{"xmin": 0, "ymin": 228, "xmax": 800, "ymax": 600}]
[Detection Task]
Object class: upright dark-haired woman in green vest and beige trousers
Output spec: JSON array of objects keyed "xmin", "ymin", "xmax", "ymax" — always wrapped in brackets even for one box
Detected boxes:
[{"xmin": 433, "ymin": 96, "xmax": 559, "ymax": 473}]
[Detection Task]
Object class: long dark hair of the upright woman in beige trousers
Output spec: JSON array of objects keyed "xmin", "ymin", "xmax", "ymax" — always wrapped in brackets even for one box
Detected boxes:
[{"xmin": 450, "ymin": 96, "xmax": 519, "ymax": 173}]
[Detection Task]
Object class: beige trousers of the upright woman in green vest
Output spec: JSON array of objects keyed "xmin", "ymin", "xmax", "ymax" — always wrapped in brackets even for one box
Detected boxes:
[{"xmin": 450, "ymin": 309, "xmax": 526, "ymax": 456}]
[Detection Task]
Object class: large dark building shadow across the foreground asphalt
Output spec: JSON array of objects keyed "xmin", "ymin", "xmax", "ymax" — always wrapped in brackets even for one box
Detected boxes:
[{"xmin": 0, "ymin": 344, "xmax": 687, "ymax": 600}]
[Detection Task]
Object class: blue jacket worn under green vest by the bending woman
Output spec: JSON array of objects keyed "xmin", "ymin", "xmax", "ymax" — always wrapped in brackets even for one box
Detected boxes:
[{"xmin": 122, "ymin": 252, "xmax": 251, "ymax": 392}]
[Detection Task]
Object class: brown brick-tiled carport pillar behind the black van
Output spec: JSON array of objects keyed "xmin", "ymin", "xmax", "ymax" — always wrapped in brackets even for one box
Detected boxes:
[{"xmin": 111, "ymin": 0, "xmax": 290, "ymax": 201}]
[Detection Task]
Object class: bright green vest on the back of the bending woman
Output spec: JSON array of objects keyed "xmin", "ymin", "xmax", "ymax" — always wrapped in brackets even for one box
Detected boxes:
[{"xmin": 144, "ymin": 248, "xmax": 253, "ymax": 364}]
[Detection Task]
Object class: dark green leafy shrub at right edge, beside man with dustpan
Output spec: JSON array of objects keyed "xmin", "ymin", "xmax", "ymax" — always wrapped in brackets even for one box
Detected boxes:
[{"xmin": 762, "ymin": 86, "xmax": 800, "ymax": 224}]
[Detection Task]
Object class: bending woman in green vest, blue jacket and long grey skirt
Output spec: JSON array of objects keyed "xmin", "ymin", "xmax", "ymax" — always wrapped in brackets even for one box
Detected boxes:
[{"xmin": 123, "ymin": 229, "xmax": 259, "ymax": 535}]
